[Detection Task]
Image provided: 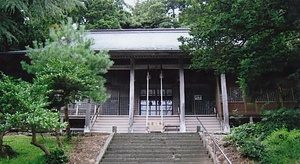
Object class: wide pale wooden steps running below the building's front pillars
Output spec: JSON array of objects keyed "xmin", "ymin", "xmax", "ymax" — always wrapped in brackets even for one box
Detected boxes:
[{"xmin": 91, "ymin": 115, "xmax": 221, "ymax": 133}]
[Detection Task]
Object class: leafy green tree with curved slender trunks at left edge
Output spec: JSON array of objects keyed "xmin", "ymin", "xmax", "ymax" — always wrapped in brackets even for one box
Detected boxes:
[{"xmin": 0, "ymin": 75, "xmax": 64, "ymax": 156}]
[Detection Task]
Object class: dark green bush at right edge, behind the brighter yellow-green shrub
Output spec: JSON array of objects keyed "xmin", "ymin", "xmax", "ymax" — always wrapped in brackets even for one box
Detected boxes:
[{"xmin": 262, "ymin": 108, "xmax": 300, "ymax": 134}]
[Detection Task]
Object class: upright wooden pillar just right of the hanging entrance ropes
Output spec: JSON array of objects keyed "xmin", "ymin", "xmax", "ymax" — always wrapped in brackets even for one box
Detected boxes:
[{"xmin": 179, "ymin": 62, "xmax": 186, "ymax": 132}]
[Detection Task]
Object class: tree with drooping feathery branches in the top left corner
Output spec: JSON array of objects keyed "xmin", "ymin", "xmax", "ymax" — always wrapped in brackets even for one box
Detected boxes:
[{"xmin": 0, "ymin": 0, "xmax": 84, "ymax": 51}]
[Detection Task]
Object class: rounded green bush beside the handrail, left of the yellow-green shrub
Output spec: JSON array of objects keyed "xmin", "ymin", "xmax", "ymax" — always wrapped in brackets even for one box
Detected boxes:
[{"xmin": 229, "ymin": 123, "xmax": 264, "ymax": 160}]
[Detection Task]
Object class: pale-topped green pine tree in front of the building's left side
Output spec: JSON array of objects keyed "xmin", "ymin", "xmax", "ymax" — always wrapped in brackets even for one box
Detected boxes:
[{"xmin": 22, "ymin": 19, "xmax": 113, "ymax": 137}]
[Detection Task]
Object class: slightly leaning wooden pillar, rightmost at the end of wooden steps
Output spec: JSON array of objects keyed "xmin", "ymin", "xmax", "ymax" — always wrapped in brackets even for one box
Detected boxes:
[{"xmin": 221, "ymin": 74, "xmax": 230, "ymax": 133}]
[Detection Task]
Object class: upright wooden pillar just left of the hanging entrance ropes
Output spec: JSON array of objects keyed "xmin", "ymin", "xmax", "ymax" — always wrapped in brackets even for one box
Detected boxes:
[{"xmin": 128, "ymin": 58, "xmax": 134, "ymax": 133}]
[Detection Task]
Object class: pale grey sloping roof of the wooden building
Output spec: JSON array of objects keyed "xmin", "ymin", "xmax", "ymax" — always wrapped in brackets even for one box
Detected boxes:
[{"xmin": 87, "ymin": 29, "xmax": 189, "ymax": 51}]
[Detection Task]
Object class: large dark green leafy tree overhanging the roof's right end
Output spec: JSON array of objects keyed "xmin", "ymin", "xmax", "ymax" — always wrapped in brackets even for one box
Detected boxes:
[{"xmin": 180, "ymin": 0, "xmax": 300, "ymax": 95}]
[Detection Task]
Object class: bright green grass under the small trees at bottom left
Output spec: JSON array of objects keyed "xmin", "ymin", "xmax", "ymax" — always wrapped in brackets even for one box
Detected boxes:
[{"xmin": 0, "ymin": 135, "xmax": 75, "ymax": 164}]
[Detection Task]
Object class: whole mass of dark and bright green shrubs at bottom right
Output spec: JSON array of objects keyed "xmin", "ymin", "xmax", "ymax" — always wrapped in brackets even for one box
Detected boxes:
[{"xmin": 229, "ymin": 108, "xmax": 300, "ymax": 163}]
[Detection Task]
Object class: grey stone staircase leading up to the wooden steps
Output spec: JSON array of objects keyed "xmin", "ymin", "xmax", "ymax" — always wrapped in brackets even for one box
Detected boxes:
[{"xmin": 100, "ymin": 133, "xmax": 213, "ymax": 164}]
